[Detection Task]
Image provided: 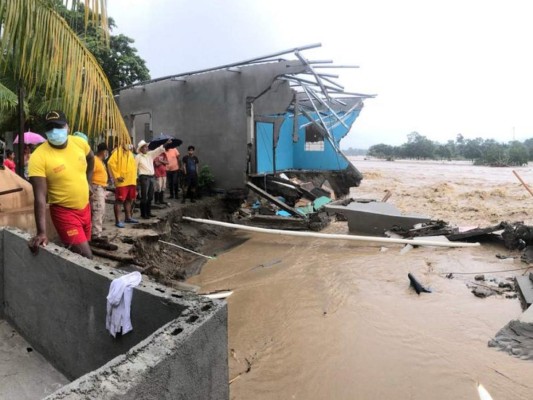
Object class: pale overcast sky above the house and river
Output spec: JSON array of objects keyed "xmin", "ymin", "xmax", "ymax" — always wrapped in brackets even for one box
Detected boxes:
[{"xmin": 108, "ymin": 0, "xmax": 533, "ymax": 148}]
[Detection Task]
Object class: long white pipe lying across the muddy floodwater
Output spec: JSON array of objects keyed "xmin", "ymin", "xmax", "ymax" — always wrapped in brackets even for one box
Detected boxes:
[{"xmin": 183, "ymin": 217, "xmax": 479, "ymax": 247}]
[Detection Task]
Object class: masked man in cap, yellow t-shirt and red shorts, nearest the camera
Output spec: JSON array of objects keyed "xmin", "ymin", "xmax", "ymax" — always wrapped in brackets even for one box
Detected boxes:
[{"xmin": 28, "ymin": 111, "xmax": 94, "ymax": 258}]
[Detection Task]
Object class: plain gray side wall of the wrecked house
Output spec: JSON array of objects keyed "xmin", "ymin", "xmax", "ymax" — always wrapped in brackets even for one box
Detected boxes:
[{"xmin": 118, "ymin": 61, "xmax": 306, "ymax": 189}]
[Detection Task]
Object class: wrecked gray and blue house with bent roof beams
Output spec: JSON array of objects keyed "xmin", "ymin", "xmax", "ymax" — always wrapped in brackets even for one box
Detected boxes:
[{"xmin": 117, "ymin": 44, "xmax": 373, "ymax": 226}]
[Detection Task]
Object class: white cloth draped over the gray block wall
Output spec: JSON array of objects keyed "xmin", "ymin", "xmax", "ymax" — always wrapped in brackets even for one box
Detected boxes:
[{"xmin": 105, "ymin": 271, "xmax": 142, "ymax": 337}]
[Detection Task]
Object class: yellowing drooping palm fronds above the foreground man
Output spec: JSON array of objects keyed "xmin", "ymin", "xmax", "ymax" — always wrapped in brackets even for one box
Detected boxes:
[{"xmin": 0, "ymin": 0, "xmax": 129, "ymax": 142}]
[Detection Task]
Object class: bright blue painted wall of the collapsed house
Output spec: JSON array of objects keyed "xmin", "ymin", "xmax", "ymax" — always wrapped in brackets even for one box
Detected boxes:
[{"xmin": 256, "ymin": 110, "xmax": 360, "ymax": 173}]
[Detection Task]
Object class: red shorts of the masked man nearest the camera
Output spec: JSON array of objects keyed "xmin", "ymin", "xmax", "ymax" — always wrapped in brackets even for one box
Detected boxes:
[{"xmin": 50, "ymin": 204, "xmax": 91, "ymax": 246}]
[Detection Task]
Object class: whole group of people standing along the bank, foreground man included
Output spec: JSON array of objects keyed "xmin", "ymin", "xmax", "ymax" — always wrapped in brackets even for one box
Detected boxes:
[{"xmin": 28, "ymin": 111, "xmax": 199, "ymax": 258}]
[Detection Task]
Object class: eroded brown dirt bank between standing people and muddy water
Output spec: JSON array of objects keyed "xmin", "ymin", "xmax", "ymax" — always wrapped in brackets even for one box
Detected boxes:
[{"xmin": 93, "ymin": 197, "xmax": 241, "ymax": 289}]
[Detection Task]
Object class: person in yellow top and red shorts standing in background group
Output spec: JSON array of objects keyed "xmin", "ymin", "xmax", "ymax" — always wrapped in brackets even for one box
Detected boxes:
[{"xmin": 107, "ymin": 143, "xmax": 139, "ymax": 228}]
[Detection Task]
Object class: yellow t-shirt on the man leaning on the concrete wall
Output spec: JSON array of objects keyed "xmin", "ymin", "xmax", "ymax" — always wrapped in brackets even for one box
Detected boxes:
[{"xmin": 28, "ymin": 135, "xmax": 91, "ymax": 210}]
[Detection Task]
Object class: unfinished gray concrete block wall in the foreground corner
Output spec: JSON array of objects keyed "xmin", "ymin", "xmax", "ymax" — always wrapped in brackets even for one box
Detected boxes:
[{"xmin": 0, "ymin": 229, "xmax": 229, "ymax": 399}]
